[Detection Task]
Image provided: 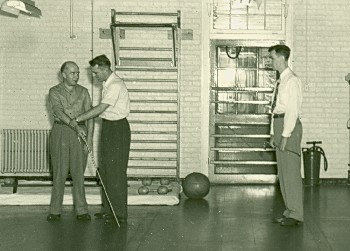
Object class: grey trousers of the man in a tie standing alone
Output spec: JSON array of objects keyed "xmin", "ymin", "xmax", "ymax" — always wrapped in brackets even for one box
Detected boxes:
[{"xmin": 274, "ymin": 118, "xmax": 304, "ymax": 221}]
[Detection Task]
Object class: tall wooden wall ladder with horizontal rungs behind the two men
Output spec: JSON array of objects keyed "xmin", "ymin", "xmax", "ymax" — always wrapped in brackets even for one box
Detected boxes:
[{"xmin": 110, "ymin": 9, "xmax": 181, "ymax": 178}]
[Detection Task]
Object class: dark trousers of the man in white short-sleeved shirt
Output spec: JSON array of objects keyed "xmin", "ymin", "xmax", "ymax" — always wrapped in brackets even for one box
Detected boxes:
[{"xmin": 99, "ymin": 118, "xmax": 131, "ymax": 218}]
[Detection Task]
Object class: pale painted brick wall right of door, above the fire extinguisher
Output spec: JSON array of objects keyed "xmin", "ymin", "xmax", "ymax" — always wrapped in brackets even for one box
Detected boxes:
[{"xmin": 293, "ymin": 0, "xmax": 350, "ymax": 178}]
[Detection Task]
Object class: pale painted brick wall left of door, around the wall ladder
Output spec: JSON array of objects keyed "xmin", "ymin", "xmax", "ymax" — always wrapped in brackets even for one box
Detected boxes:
[{"xmin": 0, "ymin": 0, "xmax": 201, "ymax": 176}]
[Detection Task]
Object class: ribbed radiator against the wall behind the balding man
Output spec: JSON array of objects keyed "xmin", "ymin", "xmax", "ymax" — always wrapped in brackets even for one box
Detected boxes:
[{"xmin": 1, "ymin": 129, "xmax": 50, "ymax": 176}]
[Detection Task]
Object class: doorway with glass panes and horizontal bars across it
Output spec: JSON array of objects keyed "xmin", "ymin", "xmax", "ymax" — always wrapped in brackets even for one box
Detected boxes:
[{"xmin": 209, "ymin": 40, "xmax": 280, "ymax": 183}]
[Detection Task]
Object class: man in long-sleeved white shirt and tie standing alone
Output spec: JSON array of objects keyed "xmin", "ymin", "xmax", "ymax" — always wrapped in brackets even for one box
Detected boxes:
[{"xmin": 268, "ymin": 45, "xmax": 304, "ymax": 226}]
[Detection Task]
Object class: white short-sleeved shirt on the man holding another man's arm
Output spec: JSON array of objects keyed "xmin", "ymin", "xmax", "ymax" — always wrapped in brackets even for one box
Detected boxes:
[{"xmin": 100, "ymin": 73, "xmax": 130, "ymax": 120}]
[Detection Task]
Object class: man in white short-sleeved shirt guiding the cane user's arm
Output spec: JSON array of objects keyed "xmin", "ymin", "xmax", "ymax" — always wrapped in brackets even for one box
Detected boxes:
[{"xmin": 75, "ymin": 55, "xmax": 131, "ymax": 223}]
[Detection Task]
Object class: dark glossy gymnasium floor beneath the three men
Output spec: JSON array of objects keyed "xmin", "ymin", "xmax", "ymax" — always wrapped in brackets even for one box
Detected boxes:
[{"xmin": 0, "ymin": 185, "xmax": 350, "ymax": 251}]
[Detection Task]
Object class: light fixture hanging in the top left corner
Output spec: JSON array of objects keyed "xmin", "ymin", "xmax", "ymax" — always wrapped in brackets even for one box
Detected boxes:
[{"xmin": 1, "ymin": 0, "xmax": 41, "ymax": 17}]
